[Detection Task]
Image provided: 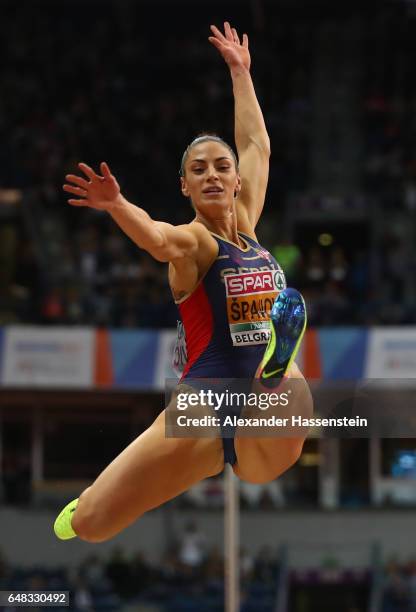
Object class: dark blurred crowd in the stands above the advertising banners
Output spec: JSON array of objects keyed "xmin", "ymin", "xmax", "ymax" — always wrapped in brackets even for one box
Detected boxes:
[{"xmin": 0, "ymin": 1, "xmax": 416, "ymax": 327}]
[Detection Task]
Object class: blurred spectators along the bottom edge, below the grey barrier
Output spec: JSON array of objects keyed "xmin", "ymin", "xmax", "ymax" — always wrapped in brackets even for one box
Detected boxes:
[{"xmin": 0, "ymin": 536, "xmax": 416, "ymax": 612}]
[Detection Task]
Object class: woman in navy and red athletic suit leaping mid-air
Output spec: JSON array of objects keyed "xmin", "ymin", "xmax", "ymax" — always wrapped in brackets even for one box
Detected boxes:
[{"xmin": 55, "ymin": 22, "xmax": 311, "ymax": 542}]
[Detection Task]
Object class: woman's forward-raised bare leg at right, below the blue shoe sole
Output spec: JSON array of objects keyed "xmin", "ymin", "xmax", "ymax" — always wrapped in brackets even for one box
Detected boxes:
[{"xmin": 233, "ymin": 363, "xmax": 313, "ymax": 484}]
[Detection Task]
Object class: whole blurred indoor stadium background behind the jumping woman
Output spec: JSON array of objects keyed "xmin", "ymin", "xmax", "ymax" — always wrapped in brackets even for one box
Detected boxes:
[{"xmin": 0, "ymin": 0, "xmax": 416, "ymax": 612}]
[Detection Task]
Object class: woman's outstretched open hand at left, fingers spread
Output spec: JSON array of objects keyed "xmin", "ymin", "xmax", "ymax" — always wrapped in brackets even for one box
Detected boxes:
[{"xmin": 63, "ymin": 162, "xmax": 120, "ymax": 210}]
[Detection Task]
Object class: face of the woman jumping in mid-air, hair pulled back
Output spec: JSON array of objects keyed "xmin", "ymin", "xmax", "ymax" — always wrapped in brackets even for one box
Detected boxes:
[{"xmin": 181, "ymin": 140, "xmax": 241, "ymax": 217}]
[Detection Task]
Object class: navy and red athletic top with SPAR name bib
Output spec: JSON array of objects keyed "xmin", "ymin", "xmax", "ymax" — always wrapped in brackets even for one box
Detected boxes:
[{"xmin": 177, "ymin": 232, "xmax": 286, "ymax": 381}]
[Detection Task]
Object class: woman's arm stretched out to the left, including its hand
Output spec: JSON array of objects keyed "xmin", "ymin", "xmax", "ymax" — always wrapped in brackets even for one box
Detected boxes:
[{"xmin": 63, "ymin": 162, "xmax": 198, "ymax": 262}]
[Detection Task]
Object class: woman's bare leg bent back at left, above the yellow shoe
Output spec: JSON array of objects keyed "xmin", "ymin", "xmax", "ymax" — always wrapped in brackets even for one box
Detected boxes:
[{"xmin": 71, "ymin": 412, "xmax": 224, "ymax": 542}]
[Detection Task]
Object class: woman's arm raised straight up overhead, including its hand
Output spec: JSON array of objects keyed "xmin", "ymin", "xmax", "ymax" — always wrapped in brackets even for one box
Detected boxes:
[{"xmin": 209, "ymin": 21, "xmax": 270, "ymax": 228}]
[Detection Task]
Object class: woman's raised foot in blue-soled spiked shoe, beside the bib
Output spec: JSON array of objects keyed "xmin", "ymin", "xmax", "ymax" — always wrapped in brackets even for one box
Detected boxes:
[{"xmin": 256, "ymin": 288, "xmax": 306, "ymax": 388}]
